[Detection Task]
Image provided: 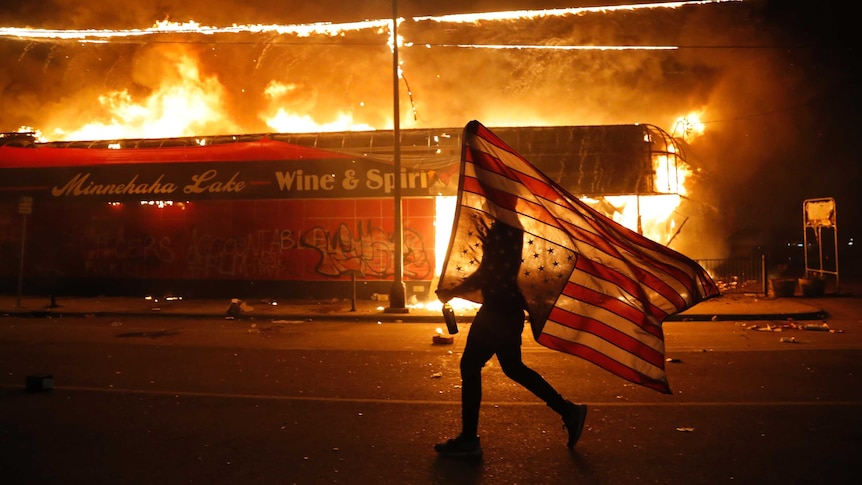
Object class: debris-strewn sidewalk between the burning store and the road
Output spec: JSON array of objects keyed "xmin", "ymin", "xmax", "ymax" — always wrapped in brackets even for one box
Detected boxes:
[{"xmin": 0, "ymin": 294, "xmax": 824, "ymax": 323}]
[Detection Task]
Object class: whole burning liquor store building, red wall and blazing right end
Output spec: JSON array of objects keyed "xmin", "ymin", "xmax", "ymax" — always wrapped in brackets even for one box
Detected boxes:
[{"xmin": 0, "ymin": 124, "xmax": 716, "ymax": 301}]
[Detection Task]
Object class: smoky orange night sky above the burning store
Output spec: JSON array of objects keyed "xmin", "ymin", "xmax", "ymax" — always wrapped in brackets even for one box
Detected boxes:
[{"xmin": 0, "ymin": 0, "xmax": 862, "ymax": 270}]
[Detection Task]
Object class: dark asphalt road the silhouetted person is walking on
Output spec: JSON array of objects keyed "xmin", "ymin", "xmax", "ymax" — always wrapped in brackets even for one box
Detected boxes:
[{"xmin": 0, "ymin": 297, "xmax": 862, "ymax": 484}]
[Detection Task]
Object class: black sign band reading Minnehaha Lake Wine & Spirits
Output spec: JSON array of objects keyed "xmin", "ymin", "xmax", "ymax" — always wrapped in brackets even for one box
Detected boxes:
[{"xmin": 0, "ymin": 159, "xmax": 457, "ymax": 202}]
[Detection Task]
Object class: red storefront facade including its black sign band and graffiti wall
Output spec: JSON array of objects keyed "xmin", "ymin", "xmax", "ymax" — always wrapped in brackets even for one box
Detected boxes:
[{"xmin": 0, "ymin": 137, "xmax": 446, "ymax": 298}]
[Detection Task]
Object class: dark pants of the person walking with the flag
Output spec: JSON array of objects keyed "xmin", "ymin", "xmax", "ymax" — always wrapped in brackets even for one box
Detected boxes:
[{"xmin": 461, "ymin": 305, "xmax": 565, "ymax": 437}]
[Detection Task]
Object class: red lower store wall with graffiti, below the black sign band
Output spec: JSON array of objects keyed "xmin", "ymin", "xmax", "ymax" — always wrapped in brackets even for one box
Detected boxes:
[{"xmin": 0, "ymin": 199, "xmax": 434, "ymax": 281}]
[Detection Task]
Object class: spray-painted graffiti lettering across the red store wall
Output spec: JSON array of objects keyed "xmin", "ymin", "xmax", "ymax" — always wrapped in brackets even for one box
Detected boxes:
[{"xmin": 69, "ymin": 222, "xmax": 432, "ymax": 280}]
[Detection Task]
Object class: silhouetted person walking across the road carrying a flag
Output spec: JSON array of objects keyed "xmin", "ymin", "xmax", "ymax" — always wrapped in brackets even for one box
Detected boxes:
[{"xmin": 434, "ymin": 221, "xmax": 587, "ymax": 458}]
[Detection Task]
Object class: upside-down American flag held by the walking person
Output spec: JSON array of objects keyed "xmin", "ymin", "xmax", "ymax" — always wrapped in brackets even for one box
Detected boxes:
[{"xmin": 437, "ymin": 121, "xmax": 719, "ymax": 394}]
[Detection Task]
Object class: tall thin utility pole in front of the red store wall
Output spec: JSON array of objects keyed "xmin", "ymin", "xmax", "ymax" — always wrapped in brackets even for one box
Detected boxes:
[{"xmin": 386, "ymin": 0, "xmax": 409, "ymax": 313}]
